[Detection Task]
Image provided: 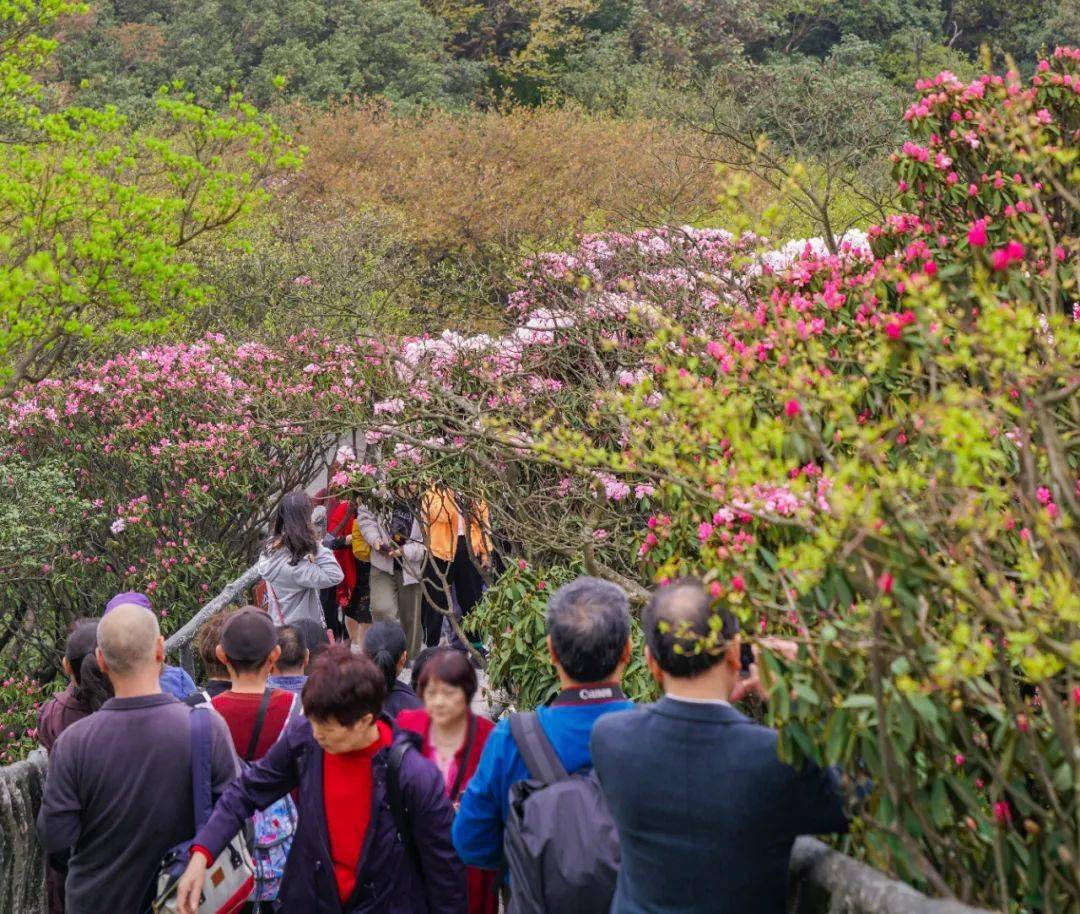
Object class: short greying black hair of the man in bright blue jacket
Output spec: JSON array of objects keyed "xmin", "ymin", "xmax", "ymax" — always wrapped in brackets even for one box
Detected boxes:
[{"xmin": 548, "ymin": 577, "xmax": 630, "ymax": 683}]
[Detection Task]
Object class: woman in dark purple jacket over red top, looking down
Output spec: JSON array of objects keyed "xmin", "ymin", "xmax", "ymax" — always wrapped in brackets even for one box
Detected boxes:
[{"xmin": 177, "ymin": 645, "xmax": 467, "ymax": 914}]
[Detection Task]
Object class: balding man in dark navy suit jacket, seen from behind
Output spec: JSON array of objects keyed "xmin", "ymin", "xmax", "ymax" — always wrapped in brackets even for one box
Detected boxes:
[{"xmin": 592, "ymin": 580, "xmax": 847, "ymax": 914}]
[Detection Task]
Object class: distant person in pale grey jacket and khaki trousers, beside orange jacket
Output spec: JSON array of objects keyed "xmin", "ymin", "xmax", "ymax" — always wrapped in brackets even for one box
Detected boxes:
[{"xmin": 356, "ymin": 496, "xmax": 428, "ymax": 657}]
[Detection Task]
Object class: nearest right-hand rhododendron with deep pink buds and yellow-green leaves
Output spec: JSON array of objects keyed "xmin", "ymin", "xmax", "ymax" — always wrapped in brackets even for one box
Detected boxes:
[{"xmin": 540, "ymin": 51, "xmax": 1080, "ymax": 912}]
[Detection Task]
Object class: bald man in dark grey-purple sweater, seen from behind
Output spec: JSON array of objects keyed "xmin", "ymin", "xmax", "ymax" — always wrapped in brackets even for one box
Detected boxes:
[{"xmin": 38, "ymin": 603, "xmax": 237, "ymax": 914}]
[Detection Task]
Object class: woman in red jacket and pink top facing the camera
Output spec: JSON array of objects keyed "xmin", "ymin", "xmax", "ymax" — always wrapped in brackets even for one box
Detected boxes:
[{"xmin": 396, "ymin": 647, "xmax": 499, "ymax": 914}]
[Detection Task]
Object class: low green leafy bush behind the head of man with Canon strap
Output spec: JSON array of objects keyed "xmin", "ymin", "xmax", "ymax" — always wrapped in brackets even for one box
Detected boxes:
[{"xmin": 469, "ymin": 560, "xmax": 658, "ymax": 710}]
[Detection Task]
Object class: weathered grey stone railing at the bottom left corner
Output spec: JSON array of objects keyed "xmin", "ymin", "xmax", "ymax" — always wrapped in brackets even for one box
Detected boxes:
[{"xmin": 0, "ymin": 750, "xmax": 45, "ymax": 914}]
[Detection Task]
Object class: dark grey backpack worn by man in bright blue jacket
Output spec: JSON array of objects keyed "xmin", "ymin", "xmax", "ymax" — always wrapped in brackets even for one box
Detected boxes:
[{"xmin": 503, "ymin": 711, "xmax": 620, "ymax": 914}]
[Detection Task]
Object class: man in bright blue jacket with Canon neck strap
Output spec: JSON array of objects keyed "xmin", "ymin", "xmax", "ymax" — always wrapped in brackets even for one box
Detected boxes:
[{"xmin": 454, "ymin": 577, "xmax": 634, "ymax": 870}]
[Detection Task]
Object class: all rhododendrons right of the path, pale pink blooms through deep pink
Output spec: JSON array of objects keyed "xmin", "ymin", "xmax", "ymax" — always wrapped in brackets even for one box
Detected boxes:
[{"xmin": 321, "ymin": 50, "xmax": 1080, "ymax": 912}]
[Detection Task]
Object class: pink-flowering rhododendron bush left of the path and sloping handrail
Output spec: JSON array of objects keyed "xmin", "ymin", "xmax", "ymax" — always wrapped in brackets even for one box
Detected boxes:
[{"xmin": 0, "ymin": 334, "xmax": 364, "ymax": 659}]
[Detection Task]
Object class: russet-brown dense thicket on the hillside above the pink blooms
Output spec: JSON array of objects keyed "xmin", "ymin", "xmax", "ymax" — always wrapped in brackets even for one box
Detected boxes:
[{"xmin": 292, "ymin": 105, "xmax": 761, "ymax": 267}]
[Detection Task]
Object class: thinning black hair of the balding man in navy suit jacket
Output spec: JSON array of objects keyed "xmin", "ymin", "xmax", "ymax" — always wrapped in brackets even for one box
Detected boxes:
[{"xmin": 642, "ymin": 578, "xmax": 739, "ymax": 680}]
